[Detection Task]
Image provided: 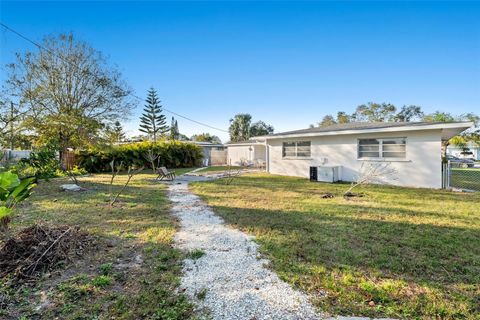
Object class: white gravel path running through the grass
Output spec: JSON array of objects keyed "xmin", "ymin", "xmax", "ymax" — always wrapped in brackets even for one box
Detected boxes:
[{"xmin": 169, "ymin": 177, "xmax": 321, "ymax": 320}]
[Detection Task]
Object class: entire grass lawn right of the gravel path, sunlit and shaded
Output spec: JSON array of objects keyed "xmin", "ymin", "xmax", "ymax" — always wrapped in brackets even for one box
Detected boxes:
[{"xmin": 191, "ymin": 174, "xmax": 480, "ymax": 319}]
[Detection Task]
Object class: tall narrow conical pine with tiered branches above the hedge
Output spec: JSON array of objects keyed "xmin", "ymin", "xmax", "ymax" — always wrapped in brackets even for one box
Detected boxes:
[{"xmin": 139, "ymin": 88, "xmax": 169, "ymax": 142}]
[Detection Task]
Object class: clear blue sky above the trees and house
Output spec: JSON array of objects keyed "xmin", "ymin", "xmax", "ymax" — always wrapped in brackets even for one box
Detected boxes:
[{"xmin": 0, "ymin": 0, "xmax": 480, "ymax": 140}]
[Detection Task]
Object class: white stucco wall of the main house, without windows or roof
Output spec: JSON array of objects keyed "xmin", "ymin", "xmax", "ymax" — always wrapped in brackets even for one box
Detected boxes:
[{"xmin": 268, "ymin": 130, "xmax": 442, "ymax": 188}]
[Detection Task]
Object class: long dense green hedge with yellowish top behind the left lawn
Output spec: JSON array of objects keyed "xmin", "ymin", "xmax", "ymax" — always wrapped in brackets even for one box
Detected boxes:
[{"xmin": 75, "ymin": 141, "xmax": 203, "ymax": 172}]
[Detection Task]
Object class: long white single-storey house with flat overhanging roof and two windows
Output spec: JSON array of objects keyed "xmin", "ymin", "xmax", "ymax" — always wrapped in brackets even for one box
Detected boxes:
[{"xmin": 251, "ymin": 122, "xmax": 473, "ymax": 188}]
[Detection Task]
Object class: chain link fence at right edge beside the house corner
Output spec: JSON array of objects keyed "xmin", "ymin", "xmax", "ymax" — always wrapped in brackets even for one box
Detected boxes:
[{"xmin": 443, "ymin": 161, "xmax": 480, "ymax": 191}]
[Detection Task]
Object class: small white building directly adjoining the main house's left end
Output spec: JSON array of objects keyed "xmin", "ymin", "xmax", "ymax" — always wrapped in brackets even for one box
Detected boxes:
[{"xmin": 227, "ymin": 140, "xmax": 267, "ymax": 167}]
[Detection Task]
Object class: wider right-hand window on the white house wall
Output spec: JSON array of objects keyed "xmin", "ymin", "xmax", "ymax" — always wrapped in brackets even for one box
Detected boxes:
[{"xmin": 358, "ymin": 138, "xmax": 407, "ymax": 159}]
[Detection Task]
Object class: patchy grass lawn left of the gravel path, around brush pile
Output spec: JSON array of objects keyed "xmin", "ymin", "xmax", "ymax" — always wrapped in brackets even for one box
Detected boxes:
[{"xmin": 0, "ymin": 169, "xmax": 197, "ymax": 319}]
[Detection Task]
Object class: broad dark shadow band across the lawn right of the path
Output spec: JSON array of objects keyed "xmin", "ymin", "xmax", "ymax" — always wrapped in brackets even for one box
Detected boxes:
[{"xmin": 213, "ymin": 204, "xmax": 480, "ymax": 285}]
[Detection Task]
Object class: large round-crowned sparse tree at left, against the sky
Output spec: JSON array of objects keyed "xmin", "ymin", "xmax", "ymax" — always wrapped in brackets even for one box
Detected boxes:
[{"xmin": 7, "ymin": 34, "xmax": 135, "ymax": 153}]
